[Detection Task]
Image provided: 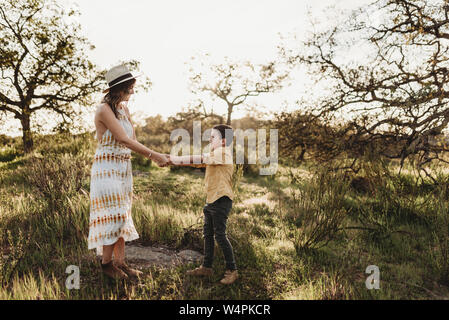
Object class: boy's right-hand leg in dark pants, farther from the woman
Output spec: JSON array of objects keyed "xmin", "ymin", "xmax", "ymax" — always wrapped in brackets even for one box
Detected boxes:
[{"xmin": 212, "ymin": 197, "xmax": 237, "ymax": 271}]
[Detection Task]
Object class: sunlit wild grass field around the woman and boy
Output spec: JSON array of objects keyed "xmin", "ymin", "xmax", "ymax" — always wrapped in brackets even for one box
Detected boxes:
[{"xmin": 0, "ymin": 135, "xmax": 449, "ymax": 299}]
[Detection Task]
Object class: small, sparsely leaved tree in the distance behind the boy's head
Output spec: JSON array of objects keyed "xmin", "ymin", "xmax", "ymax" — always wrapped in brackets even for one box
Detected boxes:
[{"xmin": 190, "ymin": 57, "xmax": 288, "ymax": 125}]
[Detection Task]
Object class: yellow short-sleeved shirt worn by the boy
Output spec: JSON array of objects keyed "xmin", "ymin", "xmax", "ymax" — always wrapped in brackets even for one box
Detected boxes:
[{"xmin": 203, "ymin": 147, "xmax": 234, "ymax": 203}]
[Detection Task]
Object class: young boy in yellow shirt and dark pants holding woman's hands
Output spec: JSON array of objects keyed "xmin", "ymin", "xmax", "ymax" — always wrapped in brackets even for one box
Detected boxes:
[{"xmin": 170, "ymin": 124, "xmax": 238, "ymax": 284}]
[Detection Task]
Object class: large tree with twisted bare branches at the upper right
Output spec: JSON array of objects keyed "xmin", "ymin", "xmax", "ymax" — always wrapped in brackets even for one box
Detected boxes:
[{"xmin": 283, "ymin": 0, "xmax": 449, "ymax": 178}]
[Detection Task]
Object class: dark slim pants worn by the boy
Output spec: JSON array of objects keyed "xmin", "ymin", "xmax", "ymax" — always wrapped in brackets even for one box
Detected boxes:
[{"xmin": 203, "ymin": 196, "xmax": 237, "ymax": 270}]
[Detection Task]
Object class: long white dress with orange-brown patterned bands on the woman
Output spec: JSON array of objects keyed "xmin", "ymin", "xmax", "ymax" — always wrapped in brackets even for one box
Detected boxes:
[{"xmin": 88, "ymin": 109, "xmax": 139, "ymax": 255}]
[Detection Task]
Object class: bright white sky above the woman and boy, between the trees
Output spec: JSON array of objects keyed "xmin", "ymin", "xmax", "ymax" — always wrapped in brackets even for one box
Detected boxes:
[{"xmin": 1, "ymin": 0, "xmax": 372, "ymax": 134}]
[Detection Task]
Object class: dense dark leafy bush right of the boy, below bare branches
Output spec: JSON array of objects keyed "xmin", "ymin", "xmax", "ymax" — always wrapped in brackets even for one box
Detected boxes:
[{"xmin": 270, "ymin": 110, "xmax": 384, "ymax": 173}]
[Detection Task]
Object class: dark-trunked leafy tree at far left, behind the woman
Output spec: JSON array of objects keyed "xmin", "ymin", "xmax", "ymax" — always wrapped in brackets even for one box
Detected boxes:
[{"xmin": 0, "ymin": 0, "xmax": 103, "ymax": 152}]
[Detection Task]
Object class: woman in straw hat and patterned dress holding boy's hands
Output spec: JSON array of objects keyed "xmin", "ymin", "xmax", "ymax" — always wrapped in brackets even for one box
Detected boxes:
[{"xmin": 88, "ymin": 65, "xmax": 168, "ymax": 279}]
